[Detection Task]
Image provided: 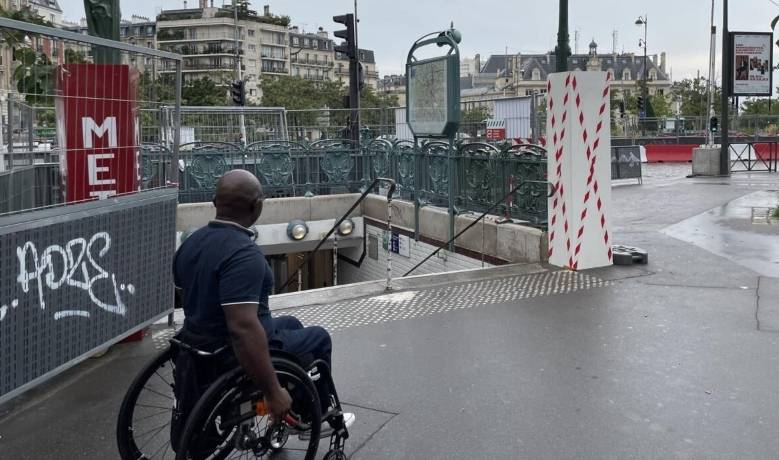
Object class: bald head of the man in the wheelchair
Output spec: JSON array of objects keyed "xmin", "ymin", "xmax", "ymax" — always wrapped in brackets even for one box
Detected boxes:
[{"xmin": 214, "ymin": 169, "xmax": 263, "ymax": 227}]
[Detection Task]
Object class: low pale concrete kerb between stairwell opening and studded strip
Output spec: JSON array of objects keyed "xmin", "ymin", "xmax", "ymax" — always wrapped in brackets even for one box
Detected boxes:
[{"xmin": 269, "ymin": 264, "xmax": 548, "ymax": 311}]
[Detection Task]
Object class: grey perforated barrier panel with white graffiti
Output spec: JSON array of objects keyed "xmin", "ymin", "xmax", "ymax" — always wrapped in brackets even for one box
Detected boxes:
[{"xmin": 0, "ymin": 189, "xmax": 176, "ymax": 402}]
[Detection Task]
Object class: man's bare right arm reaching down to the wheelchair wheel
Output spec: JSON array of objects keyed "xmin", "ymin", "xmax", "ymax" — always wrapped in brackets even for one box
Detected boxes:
[{"xmin": 224, "ymin": 303, "xmax": 292, "ymax": 420}]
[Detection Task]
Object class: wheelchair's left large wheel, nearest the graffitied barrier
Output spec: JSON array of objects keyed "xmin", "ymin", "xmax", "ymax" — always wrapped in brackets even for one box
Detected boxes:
[{"xmin": 116, "ymin": 348, "xmax": 176, "ymax": 460}]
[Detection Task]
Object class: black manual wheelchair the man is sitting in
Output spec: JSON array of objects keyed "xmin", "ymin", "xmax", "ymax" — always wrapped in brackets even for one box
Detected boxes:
[{"xmin": 116, "ymin": 338, "xmax": 349, "ymax": 460}]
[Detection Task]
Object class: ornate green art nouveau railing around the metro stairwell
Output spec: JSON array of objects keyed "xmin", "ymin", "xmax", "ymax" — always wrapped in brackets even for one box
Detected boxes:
[{"xmin": 141, "ymin": 139, "xmax": 547, "ymax": 227}]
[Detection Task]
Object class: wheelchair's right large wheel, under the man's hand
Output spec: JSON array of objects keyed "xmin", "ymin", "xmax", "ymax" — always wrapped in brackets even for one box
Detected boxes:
[{"xmin": 176, "ymin": 358, "xmax": 322, "ymax": 460}]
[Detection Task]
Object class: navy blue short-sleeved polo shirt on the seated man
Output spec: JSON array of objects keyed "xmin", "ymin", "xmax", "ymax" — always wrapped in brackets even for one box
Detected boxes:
[{"xmin": 173, "ymin": 220, "xmax": 273, "ymax": 338}]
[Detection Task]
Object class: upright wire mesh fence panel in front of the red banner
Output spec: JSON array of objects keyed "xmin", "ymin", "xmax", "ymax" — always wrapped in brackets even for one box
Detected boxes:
[{"xmin": 0, "ymin": 18, "xmax": 182, "ymax": 212}]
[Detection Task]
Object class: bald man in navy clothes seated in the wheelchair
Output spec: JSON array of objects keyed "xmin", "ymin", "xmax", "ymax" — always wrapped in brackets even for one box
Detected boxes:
[{"xmin": 173, "ymin": 170, "xmax": 355, "ymax": 445}]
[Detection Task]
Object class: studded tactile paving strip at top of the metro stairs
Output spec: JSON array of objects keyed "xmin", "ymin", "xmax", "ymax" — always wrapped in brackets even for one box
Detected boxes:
[{"xmin": 282, "ymin": 271, "xmax": 610, "ymax": 332}]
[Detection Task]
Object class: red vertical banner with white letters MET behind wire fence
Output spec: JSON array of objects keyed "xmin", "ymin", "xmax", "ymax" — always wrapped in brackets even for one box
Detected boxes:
[{"xmin": 56, "ymin": 64, "xmax": 139, "ymax": 202}]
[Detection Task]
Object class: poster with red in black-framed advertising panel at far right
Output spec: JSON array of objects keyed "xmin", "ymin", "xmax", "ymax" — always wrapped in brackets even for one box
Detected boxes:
[{"xmin": 730, "ymin": 32, "xmax": 774, "ymax": 96}]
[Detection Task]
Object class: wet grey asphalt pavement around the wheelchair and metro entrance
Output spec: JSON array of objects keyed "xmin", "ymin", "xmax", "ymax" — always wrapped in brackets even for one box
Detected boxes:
[{"xmin": 0, "ymin": 168, "xmax": 779, "ymax": 459}]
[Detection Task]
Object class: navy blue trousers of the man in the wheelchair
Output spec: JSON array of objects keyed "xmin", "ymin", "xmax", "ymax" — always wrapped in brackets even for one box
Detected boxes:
[{"xmin": 268, "ymin": 316, "xmax": 333, "ymax": 415}]
